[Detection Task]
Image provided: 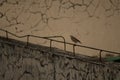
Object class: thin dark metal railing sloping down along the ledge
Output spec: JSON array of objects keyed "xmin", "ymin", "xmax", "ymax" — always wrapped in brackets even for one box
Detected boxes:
[{"xmin": 0, "ymin": 29, "xmax": 120, "ymax": 61}]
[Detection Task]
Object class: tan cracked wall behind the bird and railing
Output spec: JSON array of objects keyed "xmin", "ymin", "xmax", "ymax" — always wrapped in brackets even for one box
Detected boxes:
[{"xmin": 0, "ymin": 0, "xmax": 120, "ymax": 55}]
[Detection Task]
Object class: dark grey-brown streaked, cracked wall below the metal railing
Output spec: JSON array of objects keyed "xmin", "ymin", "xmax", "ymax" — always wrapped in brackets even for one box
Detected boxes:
[{"xmin": 0, "ymin": 37, "xmax": 120, "ymax": 80}]
